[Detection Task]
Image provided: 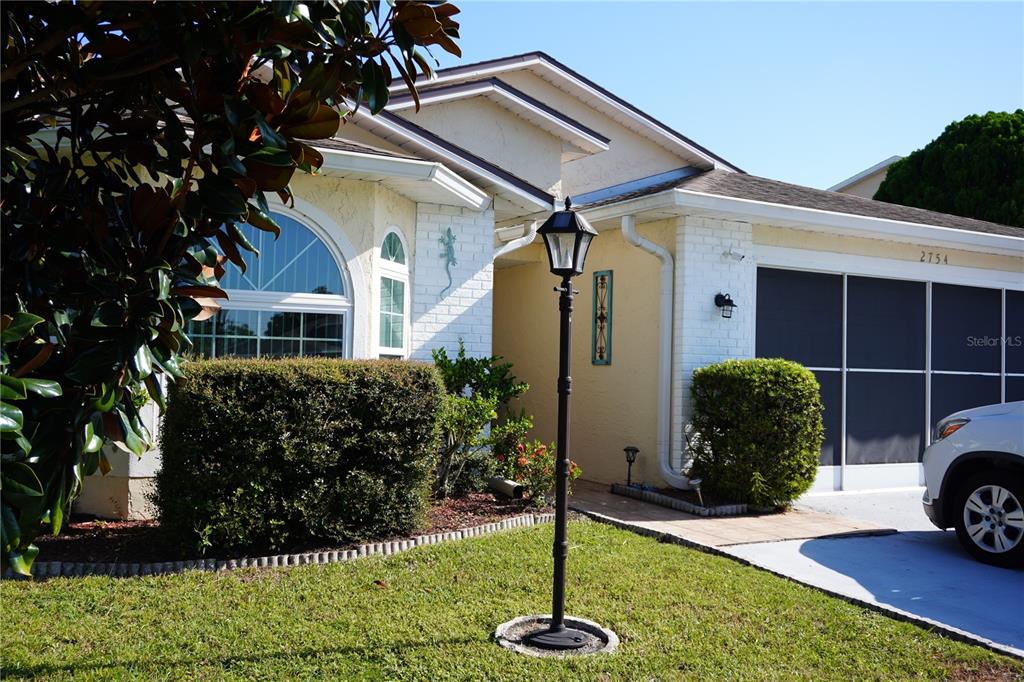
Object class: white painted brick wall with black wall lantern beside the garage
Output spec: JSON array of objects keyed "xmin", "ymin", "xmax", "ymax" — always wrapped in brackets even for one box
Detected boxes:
[{"xmin": 672, "ymin": 216, "xmax": 757, "ymax": 465}]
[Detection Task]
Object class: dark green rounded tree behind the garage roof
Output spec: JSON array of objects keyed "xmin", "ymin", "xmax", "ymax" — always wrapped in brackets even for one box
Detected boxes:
[{"xmin": 874, "ymin": 109, "xmax": 1024, "ymax": 227}]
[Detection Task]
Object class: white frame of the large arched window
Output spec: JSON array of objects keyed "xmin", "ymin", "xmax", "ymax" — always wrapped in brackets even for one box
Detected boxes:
[{"xmin": 214, "ymin": 204, "xmax": 354, "ymax": 358}]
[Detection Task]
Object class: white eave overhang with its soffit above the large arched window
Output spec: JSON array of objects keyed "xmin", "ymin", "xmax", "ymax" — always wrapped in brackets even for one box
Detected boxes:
[{"xmin": 313, "ymin": 144, "xmax": 490, "ymax": 211}]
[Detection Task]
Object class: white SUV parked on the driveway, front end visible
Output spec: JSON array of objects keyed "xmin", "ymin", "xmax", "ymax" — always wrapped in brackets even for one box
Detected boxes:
[{"xmin": 924, "ymin": 400, "xmax": 1024, "ymax": 568}]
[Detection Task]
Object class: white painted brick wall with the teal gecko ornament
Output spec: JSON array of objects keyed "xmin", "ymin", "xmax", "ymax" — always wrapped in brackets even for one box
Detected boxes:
[{"xmin": 411, "ymin": 204, "xmax": 495, "ymax": 360}]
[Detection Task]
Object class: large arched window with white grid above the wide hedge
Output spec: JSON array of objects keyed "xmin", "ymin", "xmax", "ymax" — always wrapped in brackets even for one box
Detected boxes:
[{"xmin": 188, "ymin": 213, "xmax": 352, "ymax": 357}]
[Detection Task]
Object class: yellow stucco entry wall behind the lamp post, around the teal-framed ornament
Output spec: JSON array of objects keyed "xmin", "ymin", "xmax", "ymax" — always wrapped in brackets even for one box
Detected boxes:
[{"xmin": 494, "ymin": 221, "xmax": 675, "ymax": 484}]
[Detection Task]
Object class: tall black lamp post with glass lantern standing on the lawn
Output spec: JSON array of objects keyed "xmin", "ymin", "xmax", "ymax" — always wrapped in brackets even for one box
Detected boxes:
[{"xmin": 526, "ymin": 198, "xmax": 597, "ymax": 650}]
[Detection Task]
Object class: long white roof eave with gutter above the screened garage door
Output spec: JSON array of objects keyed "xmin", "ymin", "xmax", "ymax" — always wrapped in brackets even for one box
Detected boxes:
[{"xmin": 582, "ymin": 188, "xmax": 1024, "ymax": 256}]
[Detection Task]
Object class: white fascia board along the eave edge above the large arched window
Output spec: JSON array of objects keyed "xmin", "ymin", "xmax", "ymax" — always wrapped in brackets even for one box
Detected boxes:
[{"xmin": 313, "ymin": 144, "xmax": 490, "ymax": 211}]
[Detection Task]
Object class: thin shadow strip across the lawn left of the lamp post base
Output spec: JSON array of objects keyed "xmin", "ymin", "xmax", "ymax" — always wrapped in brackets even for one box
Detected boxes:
[{"xmin": 0, "ymin": 637, "xmax": 483, "ymax": 678}]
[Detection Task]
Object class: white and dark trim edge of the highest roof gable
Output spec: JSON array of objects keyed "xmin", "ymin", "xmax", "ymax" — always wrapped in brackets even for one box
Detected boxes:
[{"xmin": 391, "ymin": 51, "xmax": 743, "ymax": 173}]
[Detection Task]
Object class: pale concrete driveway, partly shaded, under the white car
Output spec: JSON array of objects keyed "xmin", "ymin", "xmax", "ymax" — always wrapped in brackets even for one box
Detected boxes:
[{"xmin": 720, "ymin": 488, "xmax": 1024, "ymax": 656}]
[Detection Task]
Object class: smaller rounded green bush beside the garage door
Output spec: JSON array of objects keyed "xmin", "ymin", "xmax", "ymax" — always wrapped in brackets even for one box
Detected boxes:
[{"xmin": 690, "ymin": 358, "xmax": 824, "ymax": 507}]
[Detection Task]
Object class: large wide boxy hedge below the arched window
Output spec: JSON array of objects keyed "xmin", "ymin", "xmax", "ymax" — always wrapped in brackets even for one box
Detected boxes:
[{"xmin": 155, "ymin": 358, "xmax": 444, "ymax": 552}]
